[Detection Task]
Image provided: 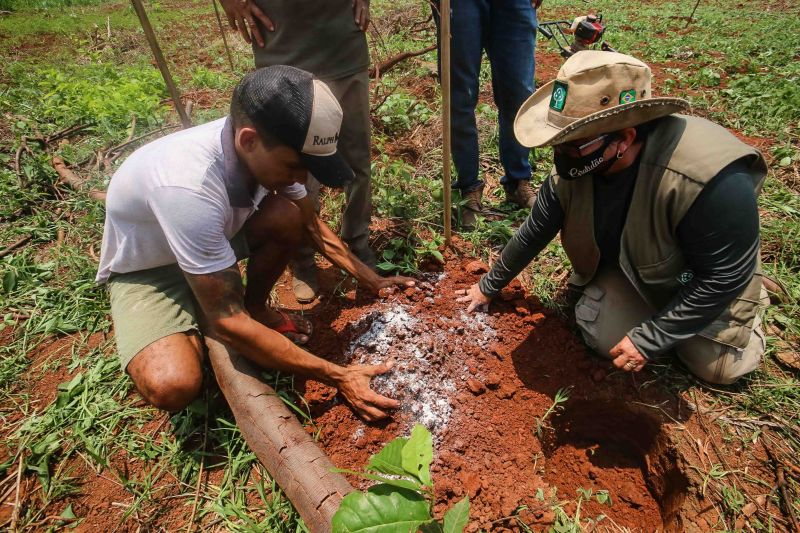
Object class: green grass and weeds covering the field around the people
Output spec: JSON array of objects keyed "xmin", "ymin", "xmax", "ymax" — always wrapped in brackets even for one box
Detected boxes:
[{"xmin": 0, "ymin": 0, "xmax": 800, "ymax": 532}]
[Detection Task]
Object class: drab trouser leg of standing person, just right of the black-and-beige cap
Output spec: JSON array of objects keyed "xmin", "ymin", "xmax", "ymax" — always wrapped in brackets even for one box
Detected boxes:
[{"xmin": 325, "ymin": 70, "xmax": 375, "ymax": 266}]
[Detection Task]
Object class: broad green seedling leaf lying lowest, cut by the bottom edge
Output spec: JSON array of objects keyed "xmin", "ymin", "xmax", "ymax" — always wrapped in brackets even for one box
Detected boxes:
[{"xmin": 333, "ymin": 484, "xmax": 432, "ymax": 533}]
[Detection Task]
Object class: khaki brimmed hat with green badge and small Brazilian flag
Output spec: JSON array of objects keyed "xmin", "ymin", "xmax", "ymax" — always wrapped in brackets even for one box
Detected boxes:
[{"xmin": 514, "ymin": 50, "xmax": 689, "ymax": 147}]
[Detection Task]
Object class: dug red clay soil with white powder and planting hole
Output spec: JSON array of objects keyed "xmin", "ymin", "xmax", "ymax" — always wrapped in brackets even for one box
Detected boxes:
[{"xmin": 279, "ymin": 258, "xmax": 688, "ymax": 531}]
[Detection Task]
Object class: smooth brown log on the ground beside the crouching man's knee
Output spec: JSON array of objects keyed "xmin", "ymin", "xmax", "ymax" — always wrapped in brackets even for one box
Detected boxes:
[{"xmin": 206, "ymin": 335, "xmax": 353, "ymax": 533}]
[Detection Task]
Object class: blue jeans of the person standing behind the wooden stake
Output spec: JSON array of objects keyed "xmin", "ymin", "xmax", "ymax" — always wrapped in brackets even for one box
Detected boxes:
[{"xmin": 434, "ymin": 0, "xmax": 537, "ymax": 192}]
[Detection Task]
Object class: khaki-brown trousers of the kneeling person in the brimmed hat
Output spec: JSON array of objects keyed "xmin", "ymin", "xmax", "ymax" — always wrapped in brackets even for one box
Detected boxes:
[{"xmin": 575, "ymin": 269, "xmax": 768, "ymax": 385}]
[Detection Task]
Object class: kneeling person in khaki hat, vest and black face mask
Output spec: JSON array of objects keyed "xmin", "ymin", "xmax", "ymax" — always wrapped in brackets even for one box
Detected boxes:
[{"xmin": 459, "ymin": 51, "xmax": 767, "ymax": 384}]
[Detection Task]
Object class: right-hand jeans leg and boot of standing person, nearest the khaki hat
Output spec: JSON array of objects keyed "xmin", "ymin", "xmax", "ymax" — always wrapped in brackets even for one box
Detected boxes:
[{"xmin": 486, "ymin": 0, "xmax": 537, "ymax": 204}]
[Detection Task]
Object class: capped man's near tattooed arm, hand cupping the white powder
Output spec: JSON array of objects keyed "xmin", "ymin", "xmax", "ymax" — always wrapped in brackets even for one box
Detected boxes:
[{"xmin": 184, "ymin": 263, "xmax": 399, "ymax": 421}]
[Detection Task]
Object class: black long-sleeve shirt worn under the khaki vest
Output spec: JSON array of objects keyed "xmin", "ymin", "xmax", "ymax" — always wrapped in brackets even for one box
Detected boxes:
[{"xmin": 480, "ymin": 163, "xmax": 759, "ymax": 357}]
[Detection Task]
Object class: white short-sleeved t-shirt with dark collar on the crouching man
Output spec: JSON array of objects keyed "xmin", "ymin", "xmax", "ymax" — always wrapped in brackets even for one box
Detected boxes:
[{"xmin": 96, "ymin": 118, "xmax": 306, "ymax": 283}]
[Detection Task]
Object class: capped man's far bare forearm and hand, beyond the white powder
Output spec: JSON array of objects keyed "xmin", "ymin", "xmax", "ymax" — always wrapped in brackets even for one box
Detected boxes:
[{"xmin": 295, "ymin": 197, "xmax": 416, "ymax": 294}]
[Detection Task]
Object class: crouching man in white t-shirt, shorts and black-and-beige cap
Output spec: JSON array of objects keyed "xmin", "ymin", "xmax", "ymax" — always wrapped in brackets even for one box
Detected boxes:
[{"xmin": 97, "ymin": 65, "xmax": 413, "ymax": 420}]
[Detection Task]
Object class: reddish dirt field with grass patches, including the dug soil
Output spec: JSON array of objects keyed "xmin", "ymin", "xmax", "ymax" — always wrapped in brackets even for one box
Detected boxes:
[{"xmin": 0, "ymin": 0, "xmax": 800, "ymax": 533}]
